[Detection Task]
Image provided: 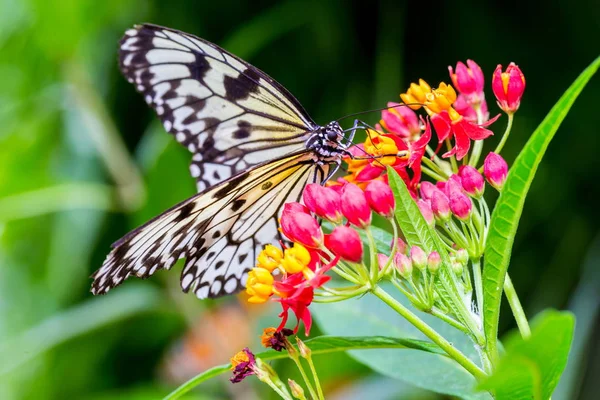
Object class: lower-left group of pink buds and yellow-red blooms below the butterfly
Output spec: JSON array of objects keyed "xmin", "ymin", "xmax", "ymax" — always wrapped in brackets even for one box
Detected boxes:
[{"xmin": 246, "ymin": 181, "xmax": 395, "ymax": 335}]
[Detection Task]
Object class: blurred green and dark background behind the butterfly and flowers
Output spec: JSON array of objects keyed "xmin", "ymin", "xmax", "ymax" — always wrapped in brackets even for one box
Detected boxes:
[{"xmin": 0, "ymin": 0, "xmax": 600, "ymax": 400}]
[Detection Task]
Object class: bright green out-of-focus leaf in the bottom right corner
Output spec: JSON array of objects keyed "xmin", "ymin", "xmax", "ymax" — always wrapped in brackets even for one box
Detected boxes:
[{"xmin": 479, "ymin": 310, "xmax": 575, "ymax": 400}]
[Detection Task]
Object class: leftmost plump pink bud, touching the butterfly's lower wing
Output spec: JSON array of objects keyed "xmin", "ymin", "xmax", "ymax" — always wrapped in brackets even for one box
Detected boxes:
[{"xmin": 279, "ymin": 203, "xmax": 323, "ymax": 248}]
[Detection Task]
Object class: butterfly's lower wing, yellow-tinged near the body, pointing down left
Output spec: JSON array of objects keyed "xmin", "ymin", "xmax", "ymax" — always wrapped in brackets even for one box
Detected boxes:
[{"xmin": 92, "ymin": 151, "xmax": 329, "ymax": 299}]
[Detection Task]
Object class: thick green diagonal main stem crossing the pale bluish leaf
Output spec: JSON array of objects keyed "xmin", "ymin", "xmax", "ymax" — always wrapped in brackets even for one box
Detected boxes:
[{"xmin": 372, "ymin": 285, "xmax": 487, "ymax": 380}]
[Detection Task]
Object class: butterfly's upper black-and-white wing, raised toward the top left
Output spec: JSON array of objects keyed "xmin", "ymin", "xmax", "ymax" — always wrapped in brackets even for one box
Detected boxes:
[{"xmin": 119, "ymin": 24, "xmax": 317, "ymax": 191}]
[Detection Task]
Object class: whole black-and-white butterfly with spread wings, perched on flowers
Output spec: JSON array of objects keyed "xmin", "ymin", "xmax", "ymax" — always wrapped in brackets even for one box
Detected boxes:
[{"xmin": 92, "ymin": 24, "xmax": 354, "ymax": 298}]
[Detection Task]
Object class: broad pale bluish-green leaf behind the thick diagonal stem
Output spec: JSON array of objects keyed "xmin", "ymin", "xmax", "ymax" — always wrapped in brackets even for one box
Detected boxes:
[{"xmin": 311, "ymin": 282, "xmax": 491, "ymax": 400}]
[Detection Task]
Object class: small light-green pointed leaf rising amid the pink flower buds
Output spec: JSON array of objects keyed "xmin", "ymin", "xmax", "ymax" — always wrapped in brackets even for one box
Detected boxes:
[{"xmin": 388, "ymin": 167, "xmax": 478, "ymax": 332}]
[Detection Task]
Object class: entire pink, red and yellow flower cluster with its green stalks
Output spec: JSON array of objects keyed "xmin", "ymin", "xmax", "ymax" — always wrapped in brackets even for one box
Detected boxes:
[{"xmin": 232, "ymin": 60, "xmax": 525, "ymax": 398}]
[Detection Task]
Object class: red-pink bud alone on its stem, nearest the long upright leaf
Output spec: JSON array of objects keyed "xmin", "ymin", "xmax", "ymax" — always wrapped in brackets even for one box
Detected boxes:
[{"xmin": 492, "ymin": 63, "xmax": 525, "ymax": 114}]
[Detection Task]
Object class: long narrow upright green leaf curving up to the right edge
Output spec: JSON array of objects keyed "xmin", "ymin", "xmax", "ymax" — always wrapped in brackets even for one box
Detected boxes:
[{"xmin": 483, "ymin": 57, "xmax": 600, "ymax": 354}]
